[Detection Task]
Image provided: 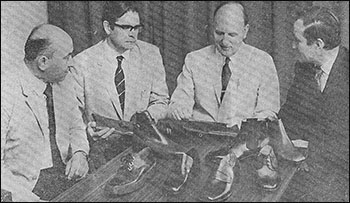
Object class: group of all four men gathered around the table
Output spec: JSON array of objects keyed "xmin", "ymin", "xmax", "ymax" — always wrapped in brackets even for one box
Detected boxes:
[{"xmin": 1, "ymin": 2, "xmax": 349, "ymax": 201}]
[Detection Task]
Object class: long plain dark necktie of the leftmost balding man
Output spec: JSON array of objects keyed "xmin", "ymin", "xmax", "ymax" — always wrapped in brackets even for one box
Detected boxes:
[{"xmin": 44, "ymin": 83, "xmax": 63, "ymax": 168}]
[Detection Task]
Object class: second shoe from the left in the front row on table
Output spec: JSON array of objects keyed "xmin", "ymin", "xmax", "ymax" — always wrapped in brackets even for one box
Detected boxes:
[{"xmin": 164, "ymin": 148, "xmax": 200, "ymax": 194}]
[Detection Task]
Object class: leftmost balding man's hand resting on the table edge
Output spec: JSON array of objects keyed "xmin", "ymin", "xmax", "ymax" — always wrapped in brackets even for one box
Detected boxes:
[{"xmin": 65, "ymin": 151, "xmax": 89, "ymax": 180}]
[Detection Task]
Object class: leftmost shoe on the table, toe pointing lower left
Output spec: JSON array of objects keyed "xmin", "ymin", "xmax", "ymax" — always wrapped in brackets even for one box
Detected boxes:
[{"xmin": 105, "ymin": 147, "xmax": 157, "ymax": 195}]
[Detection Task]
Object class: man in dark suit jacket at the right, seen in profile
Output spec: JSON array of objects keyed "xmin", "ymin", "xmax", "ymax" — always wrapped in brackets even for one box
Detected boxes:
[{"xmin": 279, "ymin": 7, "xmax": 349, "ymax": 201}]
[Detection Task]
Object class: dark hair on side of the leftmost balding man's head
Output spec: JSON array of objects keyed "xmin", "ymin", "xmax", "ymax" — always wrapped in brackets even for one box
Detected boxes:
[{"xmin": 24, "ymin": 25, "xmax": 53, "ymax": 61}]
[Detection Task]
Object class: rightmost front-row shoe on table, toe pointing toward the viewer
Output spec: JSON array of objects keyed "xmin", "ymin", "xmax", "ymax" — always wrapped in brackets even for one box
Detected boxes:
[{"xmin": 255, "ymin": 145, "xmax": 281, "ymax": 191}]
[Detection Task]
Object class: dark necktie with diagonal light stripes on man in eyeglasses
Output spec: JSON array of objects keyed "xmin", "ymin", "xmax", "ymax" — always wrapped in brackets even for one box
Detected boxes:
[{"xmin": 114, "ymin": 56, "xmax": 125, "ymax": 114}]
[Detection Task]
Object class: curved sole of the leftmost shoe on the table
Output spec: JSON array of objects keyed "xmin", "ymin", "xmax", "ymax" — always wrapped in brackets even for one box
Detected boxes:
[{"xmin": 105, "ymin": 160, "xmax": 157, "ymax": 196}]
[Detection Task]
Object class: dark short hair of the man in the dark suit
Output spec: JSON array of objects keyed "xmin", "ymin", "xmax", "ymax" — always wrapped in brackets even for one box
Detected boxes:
[{"xmin": 299, "ymin": 6, "xmax": 341, "ymax": 50}]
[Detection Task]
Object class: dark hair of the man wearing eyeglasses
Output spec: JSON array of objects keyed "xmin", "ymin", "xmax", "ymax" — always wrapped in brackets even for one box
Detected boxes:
[{"xmin": 102, "ymin": 1, "xmax": 139, "ymax": 29}]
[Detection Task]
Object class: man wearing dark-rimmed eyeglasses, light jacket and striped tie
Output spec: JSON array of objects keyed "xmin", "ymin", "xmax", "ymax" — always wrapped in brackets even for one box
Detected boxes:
[{"xmin": 74, "ymin": 2, "xmax": 169, "ymax": 168}]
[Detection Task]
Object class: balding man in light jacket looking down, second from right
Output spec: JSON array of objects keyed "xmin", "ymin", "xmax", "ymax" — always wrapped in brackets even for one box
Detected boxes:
[{"xmin": 169, "ymin": 2, "xmax": 280, "ymax": 125}]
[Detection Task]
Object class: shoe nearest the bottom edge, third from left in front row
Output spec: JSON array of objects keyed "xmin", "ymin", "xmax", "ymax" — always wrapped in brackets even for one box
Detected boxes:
[{"xmin": 199, "ymin": 148, "xmax": 238, "ymax": 202}]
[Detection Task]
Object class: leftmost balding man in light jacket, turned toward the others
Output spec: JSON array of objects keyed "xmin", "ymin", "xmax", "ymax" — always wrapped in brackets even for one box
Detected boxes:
[{"xmin": 1, "ymin": 24, "xmax": 89, "ymax": 201}]
